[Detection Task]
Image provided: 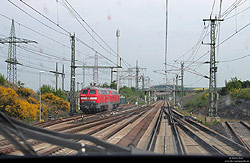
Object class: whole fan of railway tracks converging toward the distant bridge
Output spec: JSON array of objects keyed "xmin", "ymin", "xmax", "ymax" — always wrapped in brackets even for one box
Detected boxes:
[{"xmin": 0, "ymin": 101, "xmax": 250, "ymax": 157}]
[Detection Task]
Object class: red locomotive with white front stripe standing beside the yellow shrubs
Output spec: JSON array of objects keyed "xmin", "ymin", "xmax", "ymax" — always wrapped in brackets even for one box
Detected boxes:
[{"xmin": 80, "ymin": 86, "xmax": 120, "ymax": 113}]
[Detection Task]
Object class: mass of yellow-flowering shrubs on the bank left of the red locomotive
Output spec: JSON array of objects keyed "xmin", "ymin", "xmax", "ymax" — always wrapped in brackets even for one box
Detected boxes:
[{"xmin": 0, "ymin": 86, "xmax": 67, "ymax": 121}]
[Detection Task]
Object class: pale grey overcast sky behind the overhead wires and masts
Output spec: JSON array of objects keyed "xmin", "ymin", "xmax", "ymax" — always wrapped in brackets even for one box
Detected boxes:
[{"xmin": 0, "ymin": 0, "xmax": 250, "ymax": 90}]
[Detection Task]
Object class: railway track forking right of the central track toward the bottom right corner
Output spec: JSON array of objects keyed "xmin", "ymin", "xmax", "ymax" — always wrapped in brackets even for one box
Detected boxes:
[{"xmin": 166, "ymin": 104, "xmax": 250, "ymax": 156}]
